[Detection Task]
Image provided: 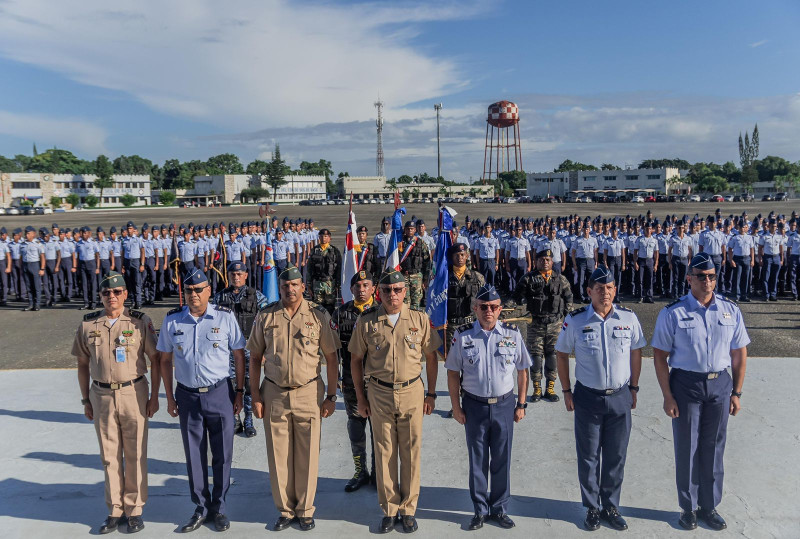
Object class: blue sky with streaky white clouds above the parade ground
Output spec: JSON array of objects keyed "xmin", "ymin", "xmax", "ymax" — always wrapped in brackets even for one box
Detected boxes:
[{"xmin": 0, "ymin": 0, "xmax": 800, "ymax": 180}]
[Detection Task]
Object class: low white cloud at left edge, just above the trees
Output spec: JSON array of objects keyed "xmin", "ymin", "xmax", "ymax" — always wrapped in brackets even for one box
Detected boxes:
[{"xmin": 0, "ymin": 110, "xmax": 108, "ymax": 156}]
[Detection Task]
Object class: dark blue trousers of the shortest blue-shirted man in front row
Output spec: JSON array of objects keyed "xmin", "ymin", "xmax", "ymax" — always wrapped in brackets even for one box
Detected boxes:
[{"xmin": 461, "ymin": 393, "xmax": 516, "ymax": 515}]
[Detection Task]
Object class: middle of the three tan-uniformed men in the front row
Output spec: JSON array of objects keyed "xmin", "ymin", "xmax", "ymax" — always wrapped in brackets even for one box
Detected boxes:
[{"xmin": 247, "ymin": 265, "xmax": 339, "ymax": 531}]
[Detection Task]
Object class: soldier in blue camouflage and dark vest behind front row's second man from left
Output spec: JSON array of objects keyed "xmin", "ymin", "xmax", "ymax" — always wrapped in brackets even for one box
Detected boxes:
[{"xmin": 211, "ymin": 260, "xmax": 267, "ymax": 438}]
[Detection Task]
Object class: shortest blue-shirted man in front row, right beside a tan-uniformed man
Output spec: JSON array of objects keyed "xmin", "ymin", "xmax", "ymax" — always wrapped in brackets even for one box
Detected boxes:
[{"xmin": 445, "ymin": 284, "xmax": 531, "ymax": 530}]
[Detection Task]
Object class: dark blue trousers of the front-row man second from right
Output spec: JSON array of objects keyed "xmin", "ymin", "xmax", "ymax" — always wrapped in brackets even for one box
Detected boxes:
[{"xmin": 573, "ymin": 382, "xmax": 633, "ymax": 510}]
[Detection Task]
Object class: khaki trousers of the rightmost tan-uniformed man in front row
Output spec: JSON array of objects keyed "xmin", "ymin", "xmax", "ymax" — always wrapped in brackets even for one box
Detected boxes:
[{"xmin": 367, "ymin": 380, "xmax": 425, "ymax": 516}]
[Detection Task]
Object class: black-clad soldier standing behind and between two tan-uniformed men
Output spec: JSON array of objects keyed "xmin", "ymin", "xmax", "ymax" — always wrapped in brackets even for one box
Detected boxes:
[{"xmin": 331, "ymin": 270, "xmax": 375, "ymax": 492}]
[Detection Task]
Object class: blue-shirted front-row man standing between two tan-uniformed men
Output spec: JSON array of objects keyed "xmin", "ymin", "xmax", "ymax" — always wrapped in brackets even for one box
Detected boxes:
[{"xmin": 157, "ymin": 268, "xmax": 245, "ymax": 532}]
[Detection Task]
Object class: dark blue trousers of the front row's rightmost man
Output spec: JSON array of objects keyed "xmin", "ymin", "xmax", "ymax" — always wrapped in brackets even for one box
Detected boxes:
[{"xmin": 669, "ymin": 369, "xmax": 733, "ymax": 511}]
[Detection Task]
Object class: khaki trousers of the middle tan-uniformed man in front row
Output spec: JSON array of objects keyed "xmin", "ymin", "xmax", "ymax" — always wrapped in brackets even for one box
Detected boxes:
[{"xmin": 261, "ymin": 380, "xmax": 325, "ymax": 518}]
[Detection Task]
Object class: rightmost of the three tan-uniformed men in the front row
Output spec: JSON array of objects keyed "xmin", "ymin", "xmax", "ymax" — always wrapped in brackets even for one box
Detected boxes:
[{"xmin": 348, "ymin": 270, "xmax": 442, "ymax": 533}]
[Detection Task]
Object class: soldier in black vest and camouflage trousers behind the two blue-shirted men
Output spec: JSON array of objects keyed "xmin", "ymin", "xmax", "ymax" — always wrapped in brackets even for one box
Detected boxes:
[{"xmin": 514, "ymin": 247, "xmax": 572, "ymax": 402}]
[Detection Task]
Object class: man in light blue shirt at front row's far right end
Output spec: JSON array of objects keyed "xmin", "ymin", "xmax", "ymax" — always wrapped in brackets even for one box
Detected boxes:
[{"xmin": 652, "ymin": 253, "xmax": 750, "ymax": 530}]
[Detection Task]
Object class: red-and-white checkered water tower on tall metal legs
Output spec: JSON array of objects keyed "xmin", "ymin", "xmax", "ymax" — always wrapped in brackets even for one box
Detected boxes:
[{"xmin": 481, "ymin": 101, "xmax": 522, "ymax": 183}]
